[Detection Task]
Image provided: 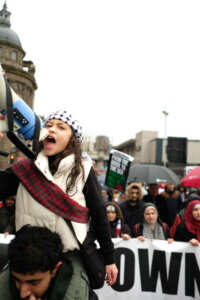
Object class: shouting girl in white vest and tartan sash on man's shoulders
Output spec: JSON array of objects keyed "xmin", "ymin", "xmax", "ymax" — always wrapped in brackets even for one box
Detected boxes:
[{"xmin": 0, "ymin": 110, "xmax": 118, "ymax": 300}]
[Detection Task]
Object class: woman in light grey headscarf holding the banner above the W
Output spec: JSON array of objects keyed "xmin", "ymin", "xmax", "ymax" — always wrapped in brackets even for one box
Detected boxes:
[{"xmin": 134, "ymin": 202, "xmax": 172, "ymax": 242}]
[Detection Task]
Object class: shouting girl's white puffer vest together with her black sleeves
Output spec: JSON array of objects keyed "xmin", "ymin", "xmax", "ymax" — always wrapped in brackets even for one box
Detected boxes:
[{"xmin": 0, "ymin": 152, "xmax": 114, "ymax": 265}]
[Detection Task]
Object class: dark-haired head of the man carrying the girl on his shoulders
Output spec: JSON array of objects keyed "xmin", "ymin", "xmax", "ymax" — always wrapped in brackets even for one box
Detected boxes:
[{"xmin": 8, "ymin": 225, "xmax": 63, "ymax": 300}]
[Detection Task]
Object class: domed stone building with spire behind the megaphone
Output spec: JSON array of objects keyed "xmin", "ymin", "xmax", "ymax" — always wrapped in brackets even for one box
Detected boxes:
[{"xmin": 0, "ymin": 1, "xmax": 37, "ymax": 169}]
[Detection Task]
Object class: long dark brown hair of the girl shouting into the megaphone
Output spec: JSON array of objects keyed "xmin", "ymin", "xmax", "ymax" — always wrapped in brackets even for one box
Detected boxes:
[{"xmin": 38, "ymin": 131, "xmax": 85, "ymax": 193}]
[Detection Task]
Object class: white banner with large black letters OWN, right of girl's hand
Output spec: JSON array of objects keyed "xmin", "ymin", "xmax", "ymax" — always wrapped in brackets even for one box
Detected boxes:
[{"xmin": 95, "ymin": 239, "xmax": 200, "ymax": 300}]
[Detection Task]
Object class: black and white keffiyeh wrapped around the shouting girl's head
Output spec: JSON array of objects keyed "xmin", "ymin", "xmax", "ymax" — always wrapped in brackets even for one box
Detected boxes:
[{"xmin": 45, "ymin": 110, "xmax": 83, "ymax": 143}]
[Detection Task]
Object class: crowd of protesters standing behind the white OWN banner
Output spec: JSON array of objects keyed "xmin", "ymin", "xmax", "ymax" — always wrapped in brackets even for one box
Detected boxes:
[{"xmin": 98, "ymin": 173, "xmax": 200, "ymax": 245}]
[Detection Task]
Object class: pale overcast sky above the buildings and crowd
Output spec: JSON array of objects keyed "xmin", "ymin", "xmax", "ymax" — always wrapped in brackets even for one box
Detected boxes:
[{"xmin": 0, "ymin": 0, "xmax": 200, "ymax": 145}]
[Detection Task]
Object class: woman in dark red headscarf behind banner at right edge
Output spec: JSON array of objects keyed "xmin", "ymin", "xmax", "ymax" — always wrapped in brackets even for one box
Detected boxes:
[{"xmin": 174, "ymin": 200, "xmax": 200, "ymax": 246}]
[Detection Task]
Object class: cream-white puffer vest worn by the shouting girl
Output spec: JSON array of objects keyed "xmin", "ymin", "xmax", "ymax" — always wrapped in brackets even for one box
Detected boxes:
[{"xmin": 16, "ymin": 151, "xmax": 92, "ymax": 252}]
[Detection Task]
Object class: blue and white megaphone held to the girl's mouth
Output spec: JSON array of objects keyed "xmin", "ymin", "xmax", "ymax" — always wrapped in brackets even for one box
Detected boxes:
[{"xmin": 0, "ymin": 65, "xmax": 48, "ymax": 158}]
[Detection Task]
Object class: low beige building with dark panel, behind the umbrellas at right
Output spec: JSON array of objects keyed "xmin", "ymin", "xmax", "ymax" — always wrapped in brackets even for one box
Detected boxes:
[{"xmin": 114, "ymin": 130, "xmax": 200, "ymax": 176}]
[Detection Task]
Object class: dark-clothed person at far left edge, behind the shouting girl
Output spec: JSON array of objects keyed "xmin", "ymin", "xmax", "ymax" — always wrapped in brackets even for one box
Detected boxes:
[{"xmin": 0, "ymin": 196, "xmax": 16, "ymax": 234}]
